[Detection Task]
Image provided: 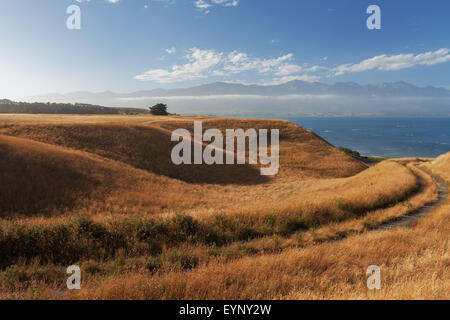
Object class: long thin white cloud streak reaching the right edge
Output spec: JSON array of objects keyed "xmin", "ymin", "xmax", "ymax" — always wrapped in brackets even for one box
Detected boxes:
[{"xmin": 331, "ymin": 48, "xmax": 450, "ymax": 76}]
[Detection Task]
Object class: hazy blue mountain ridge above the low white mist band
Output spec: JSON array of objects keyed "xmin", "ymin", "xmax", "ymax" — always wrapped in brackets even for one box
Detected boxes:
[{"xmin": 27, "ymin": 80, "xmax": 450, "ymax": 103}]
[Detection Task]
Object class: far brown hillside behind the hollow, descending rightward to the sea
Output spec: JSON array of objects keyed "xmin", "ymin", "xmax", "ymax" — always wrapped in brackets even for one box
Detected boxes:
[{"xmin": 5, "ymin": 118, "xmax": 367, "ymax": 184}]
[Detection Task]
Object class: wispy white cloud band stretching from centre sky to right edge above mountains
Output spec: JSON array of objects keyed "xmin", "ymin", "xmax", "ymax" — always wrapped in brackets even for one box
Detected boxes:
[{"xmin": 134, "ymin": 48, "xmax": 450, "ymax": 84}]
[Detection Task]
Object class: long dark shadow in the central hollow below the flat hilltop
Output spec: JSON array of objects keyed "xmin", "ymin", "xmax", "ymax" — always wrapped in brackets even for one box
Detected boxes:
[{"xmin": 7, "ymin": 125, "xmax": 270, "ymax": 185}]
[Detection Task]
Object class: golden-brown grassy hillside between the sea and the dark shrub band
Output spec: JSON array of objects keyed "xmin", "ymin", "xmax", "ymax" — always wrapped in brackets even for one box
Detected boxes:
[{"xmin": 1, "ymin": 117, "xmax": 417, "ymax": 223}]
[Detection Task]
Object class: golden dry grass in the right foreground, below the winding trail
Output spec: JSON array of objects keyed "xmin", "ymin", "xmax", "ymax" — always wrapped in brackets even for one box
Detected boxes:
[{"xmin": 64, "ymin": 154, "xmax": 450, "ymax": 299}]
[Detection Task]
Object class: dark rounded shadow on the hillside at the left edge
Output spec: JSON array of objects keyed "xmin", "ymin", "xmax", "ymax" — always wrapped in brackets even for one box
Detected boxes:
[{"xmin": 0, "ymin": 135, "xmax": 98, "ymax": 216}]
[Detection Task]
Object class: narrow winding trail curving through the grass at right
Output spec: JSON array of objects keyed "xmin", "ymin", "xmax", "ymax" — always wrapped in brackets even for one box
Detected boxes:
[{"xmin": 375, "ymin": 172, "xmax": 448, "ymax": 230}]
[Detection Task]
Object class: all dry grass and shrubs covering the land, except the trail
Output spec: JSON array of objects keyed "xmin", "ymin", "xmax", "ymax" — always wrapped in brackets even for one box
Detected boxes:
[{"xmin": 0, "ymin": 115, "xmax": 444, "ymax": 299}]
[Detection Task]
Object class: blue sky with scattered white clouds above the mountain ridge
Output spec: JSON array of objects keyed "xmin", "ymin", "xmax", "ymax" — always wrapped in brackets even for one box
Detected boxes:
[{"xmin": 0, "ymin": 0, "xmax": 450, "ymax": 98}]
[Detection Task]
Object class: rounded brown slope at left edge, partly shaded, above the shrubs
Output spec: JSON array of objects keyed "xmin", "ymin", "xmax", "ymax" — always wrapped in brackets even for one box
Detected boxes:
[{"xmin": 0, "ymin": 135, "xmax": 197, "ymax": 217}]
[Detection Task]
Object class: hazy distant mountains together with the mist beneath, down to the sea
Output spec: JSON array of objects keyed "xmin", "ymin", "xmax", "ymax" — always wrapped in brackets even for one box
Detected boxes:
[{"xmin": 26, "ymin": 80, "xmax": 450, "ymax": 117}]
